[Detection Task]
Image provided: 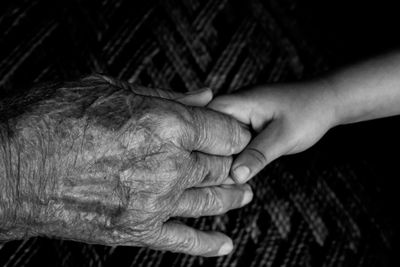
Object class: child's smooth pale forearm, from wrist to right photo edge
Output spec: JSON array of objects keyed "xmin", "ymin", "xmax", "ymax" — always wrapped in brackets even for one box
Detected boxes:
[{"xmin": 327, "ymin": 53, "xmax": 400, "ymax": 125}]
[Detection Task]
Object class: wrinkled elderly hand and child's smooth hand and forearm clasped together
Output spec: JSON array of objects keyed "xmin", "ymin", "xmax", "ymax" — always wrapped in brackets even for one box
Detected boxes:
[{"xmin": 0, "ymin": 55, "xmax": 400, "ymax": 256}]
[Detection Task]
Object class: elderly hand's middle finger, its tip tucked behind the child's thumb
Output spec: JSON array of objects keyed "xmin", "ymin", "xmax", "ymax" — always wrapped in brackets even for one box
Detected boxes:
[{"xmin": 189, "ymin": 152, "xmax": 232, "ymax": 187}]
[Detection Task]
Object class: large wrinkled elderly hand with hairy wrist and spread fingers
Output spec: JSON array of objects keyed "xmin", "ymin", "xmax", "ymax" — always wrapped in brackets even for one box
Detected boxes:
[{"xmin": 0, "ymin": 75, "xmax": 252, "ymax": 256}]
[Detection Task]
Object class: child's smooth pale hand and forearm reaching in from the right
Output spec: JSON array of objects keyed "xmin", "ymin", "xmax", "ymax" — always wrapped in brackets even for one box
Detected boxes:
[{"xmin": 208, "ymin": 52, "xmax": 400, "ymax": 183}]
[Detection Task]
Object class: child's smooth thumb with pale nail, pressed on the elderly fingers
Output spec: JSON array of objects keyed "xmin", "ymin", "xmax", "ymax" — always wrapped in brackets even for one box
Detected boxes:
[{"xmin": 231, "ymin": 121, "xmax": 288, "ymax": 183}]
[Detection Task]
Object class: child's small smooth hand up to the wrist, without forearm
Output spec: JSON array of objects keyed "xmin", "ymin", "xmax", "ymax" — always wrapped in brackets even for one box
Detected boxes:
[{"xmin": 208, "ymin": 83, "xmax": 335, "ymax": 183}]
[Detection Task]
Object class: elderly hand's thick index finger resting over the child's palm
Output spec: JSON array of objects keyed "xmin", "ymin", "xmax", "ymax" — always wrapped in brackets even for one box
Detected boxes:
[{"xmin": 189, "ymin": 108, "xmax": 251, "ymax": 156}]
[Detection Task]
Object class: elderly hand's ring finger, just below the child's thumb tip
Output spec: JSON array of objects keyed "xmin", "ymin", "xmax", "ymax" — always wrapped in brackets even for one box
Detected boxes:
[{"xmin": 172, "ymin": 184, "xmax": 253, "ymax": 218}]
